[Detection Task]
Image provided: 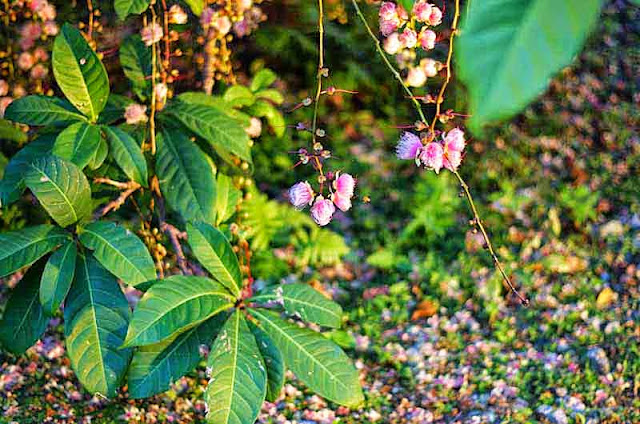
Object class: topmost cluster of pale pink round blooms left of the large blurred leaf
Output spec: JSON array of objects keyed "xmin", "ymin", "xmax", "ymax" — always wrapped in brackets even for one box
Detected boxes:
[{"xmin": 379, "ymin": 0, "xmax": 442, "ymax": 87}]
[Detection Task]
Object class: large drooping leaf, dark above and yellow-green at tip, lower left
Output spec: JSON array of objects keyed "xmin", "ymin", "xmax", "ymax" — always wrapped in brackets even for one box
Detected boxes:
[{"xmin": 64, "ymin": 255, "xmax": 131, "ymax": 398}]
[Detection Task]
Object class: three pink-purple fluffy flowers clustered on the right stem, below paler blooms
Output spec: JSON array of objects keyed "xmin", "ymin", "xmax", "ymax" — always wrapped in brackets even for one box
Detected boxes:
[{"xmin": 396, "ymin": 128, "xmax": 467, "ymax": 174}]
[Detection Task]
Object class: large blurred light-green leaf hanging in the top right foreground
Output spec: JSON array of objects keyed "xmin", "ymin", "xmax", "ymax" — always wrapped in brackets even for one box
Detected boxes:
[{"xmin": 454, "ymin": 0, "xmax": 602, "ymax": 131}]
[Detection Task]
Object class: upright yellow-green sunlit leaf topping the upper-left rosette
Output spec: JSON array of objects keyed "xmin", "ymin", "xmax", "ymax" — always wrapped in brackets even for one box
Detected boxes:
[{"xmin": 51, "ymin": 23, "xmax": 109, "ymax": 122}]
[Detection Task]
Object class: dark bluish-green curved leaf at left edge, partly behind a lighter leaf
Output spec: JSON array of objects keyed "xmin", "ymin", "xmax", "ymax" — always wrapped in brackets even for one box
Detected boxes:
[{"xmin": 0, "ymin": 134, "xmax": 55, "ymax": 206}]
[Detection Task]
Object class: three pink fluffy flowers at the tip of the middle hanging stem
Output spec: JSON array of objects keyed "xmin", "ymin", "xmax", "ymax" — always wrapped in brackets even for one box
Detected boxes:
[{"xmin": 289, "ymin": 172, "xmax": 356, "ymax": 226}]
